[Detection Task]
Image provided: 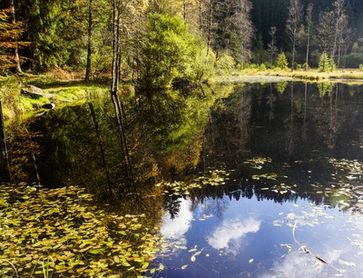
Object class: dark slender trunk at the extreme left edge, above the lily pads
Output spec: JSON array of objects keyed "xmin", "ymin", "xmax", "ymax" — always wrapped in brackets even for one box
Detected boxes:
[{"xmin": 0, "ymin": 98, "xmax": 11, "ymax": 182}]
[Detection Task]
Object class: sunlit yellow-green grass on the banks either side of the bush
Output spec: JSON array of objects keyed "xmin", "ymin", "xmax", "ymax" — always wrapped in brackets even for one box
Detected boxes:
[{"xmin": 0, "ymin": 66, "xmax": 363, "ymax": 120}]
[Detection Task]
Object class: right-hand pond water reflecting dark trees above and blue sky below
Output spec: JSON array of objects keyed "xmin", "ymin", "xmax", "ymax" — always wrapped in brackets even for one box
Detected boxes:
[{"xmin": 157, "ymin": 84, "xmax": 363, "ymax": 277}]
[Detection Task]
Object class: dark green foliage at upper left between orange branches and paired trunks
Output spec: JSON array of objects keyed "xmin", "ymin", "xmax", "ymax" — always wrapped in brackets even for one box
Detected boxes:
[{"xmin": 16, "ymin": 0, "xmax": 110, "ymax": 71}]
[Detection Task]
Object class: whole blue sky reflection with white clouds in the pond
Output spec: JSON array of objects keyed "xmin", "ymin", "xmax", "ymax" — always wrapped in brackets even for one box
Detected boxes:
[{"xmin": 158, "ymin": 197, "xmax": 363, "ymax": 278}]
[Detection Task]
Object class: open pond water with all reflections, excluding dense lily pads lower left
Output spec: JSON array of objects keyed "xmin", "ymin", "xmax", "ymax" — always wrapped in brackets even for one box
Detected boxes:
[{"xmin": 3, "ymin": 82, "xmax": 363, "ymax": 277}]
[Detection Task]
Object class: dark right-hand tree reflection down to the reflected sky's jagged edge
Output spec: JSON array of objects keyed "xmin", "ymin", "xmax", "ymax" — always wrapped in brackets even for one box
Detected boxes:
[{"xmin": 173, "ymin": 81, "xmax": 362, "ymax": 214}]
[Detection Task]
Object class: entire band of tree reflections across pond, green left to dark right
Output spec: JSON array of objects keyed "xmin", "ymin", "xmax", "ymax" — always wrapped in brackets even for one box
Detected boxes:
[{"xmin": 9, "ymin": 84, "xmax": 363, "ymax": 215}]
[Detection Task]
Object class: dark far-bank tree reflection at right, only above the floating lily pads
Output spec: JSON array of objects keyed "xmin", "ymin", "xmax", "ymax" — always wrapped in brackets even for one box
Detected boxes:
[{"xmin": 204, "ymin": 83, "xmax": 361, "ymax": 164}]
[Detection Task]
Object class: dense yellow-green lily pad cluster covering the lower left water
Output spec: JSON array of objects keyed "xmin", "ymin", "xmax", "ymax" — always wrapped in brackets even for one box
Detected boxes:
[{"xmin": 0, "ymin": 185, "xmax": 162, "ymax": 277}]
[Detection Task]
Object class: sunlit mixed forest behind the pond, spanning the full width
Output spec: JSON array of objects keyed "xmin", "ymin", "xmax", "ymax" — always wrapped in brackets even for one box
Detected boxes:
[{"xmin": 0, "ymin": 0, "xmax": 363, "ymax": 78}]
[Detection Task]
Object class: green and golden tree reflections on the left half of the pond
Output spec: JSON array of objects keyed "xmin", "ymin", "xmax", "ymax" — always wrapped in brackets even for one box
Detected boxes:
[{"xmin": 5, "ymin": 83, "xmax": 230, "ymax": 193}]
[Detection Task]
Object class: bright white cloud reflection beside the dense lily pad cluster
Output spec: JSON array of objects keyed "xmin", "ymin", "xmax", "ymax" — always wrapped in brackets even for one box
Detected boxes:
[{"xmin": 161, "ymin": 199, "xmax": 193, "ymax": 241}]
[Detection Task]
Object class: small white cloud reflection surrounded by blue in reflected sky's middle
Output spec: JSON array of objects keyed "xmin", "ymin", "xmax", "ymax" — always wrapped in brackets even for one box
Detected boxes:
[{"xmin": 207, "ymin": 218, "xmax": 261, "ymax": 254}]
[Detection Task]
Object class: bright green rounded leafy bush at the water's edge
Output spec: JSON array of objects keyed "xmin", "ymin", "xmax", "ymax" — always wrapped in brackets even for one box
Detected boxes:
[{"xmin": 141, "ymin": 13, "xmax": 214, "ymax": 89}]
